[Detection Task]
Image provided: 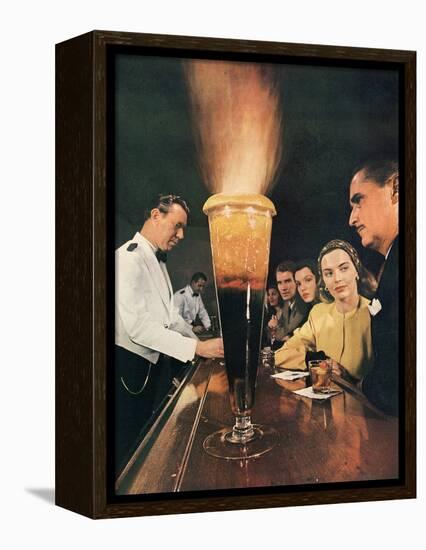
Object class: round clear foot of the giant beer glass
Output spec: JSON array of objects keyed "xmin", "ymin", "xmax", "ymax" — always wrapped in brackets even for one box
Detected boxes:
[{"xmin": 203, "ymin": 424, "xmax": 278, "ymax": 460}]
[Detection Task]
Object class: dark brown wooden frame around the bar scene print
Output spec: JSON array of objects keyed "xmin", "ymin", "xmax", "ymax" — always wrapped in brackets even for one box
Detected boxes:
[{"xmin": 56, "ymin": 31, "xmax": 416, "ymax": 518}]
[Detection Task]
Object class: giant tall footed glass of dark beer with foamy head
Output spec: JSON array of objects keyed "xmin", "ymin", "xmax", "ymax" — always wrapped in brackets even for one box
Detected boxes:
[{"xmin": 203, "ymin": 193, "xmax": 277, "ymax": 459}]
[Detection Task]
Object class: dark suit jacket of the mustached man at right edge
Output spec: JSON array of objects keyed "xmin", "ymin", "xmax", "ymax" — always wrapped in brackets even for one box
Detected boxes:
[{"xmin": 362, "ymin": 237, "xmax": 399, "ymax": 416}]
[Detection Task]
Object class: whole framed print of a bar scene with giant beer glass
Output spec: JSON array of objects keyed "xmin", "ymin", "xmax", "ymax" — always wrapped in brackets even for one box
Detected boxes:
[{"xmin": 56, "ymin": 31, "xmax": 416, "ymax": 518}]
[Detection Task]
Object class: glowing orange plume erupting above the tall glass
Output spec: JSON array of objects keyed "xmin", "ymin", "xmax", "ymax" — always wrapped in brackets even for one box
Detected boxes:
[{"xmin": 185, "ymin": 61, "xmax": 281, "ymax": 194}]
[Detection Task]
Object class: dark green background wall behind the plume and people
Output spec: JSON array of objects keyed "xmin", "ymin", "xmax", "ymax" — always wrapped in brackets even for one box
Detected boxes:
[{"xmin": 115, "ymin": 54, "xmax": 399, "ymax": 320}]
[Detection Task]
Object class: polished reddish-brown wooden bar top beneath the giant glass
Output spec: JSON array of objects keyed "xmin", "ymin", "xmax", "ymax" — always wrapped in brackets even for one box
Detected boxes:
[{"xmin": 116, "ymin": 360, "xmax": 398, "ymax": 495}]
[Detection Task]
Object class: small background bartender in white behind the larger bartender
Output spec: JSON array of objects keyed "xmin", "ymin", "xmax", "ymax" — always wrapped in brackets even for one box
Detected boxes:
[{"xmin": 174, "ymin": 271, "xmax": 211, "ymax": 334}]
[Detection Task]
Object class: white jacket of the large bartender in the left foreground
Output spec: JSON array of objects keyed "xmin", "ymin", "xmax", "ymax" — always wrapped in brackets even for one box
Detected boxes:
[{"xmin": 115, "ymin": 233, "xmax": 198, "ymax": 364}]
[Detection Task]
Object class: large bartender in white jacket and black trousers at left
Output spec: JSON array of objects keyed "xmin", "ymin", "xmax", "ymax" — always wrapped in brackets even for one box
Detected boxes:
[{"xmin": 115, "ymin": 195, "xmax": 223, "ymax": 468}]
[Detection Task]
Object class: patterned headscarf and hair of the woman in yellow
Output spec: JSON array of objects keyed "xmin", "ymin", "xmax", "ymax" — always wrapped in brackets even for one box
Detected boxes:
[{"xmin": 318, "ymin": 239, "xmax": 377, "ymax": 303}]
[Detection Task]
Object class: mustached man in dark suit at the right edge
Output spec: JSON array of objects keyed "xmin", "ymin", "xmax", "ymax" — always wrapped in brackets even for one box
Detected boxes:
[{"xmin": 349, "ymin": 160, "xmax": 399, "ymax": 416}]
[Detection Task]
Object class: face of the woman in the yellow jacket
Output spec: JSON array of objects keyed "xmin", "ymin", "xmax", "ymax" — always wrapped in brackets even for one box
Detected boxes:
[{"xmin": 321, "ymin": 248, "xmax": 358, "ymax": 302}]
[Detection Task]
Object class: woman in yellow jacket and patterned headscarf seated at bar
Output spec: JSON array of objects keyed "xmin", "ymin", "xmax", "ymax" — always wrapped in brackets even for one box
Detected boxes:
[{"xmin": 275, "ymin": 240, "xmax": 374, "ymax": 382}]
